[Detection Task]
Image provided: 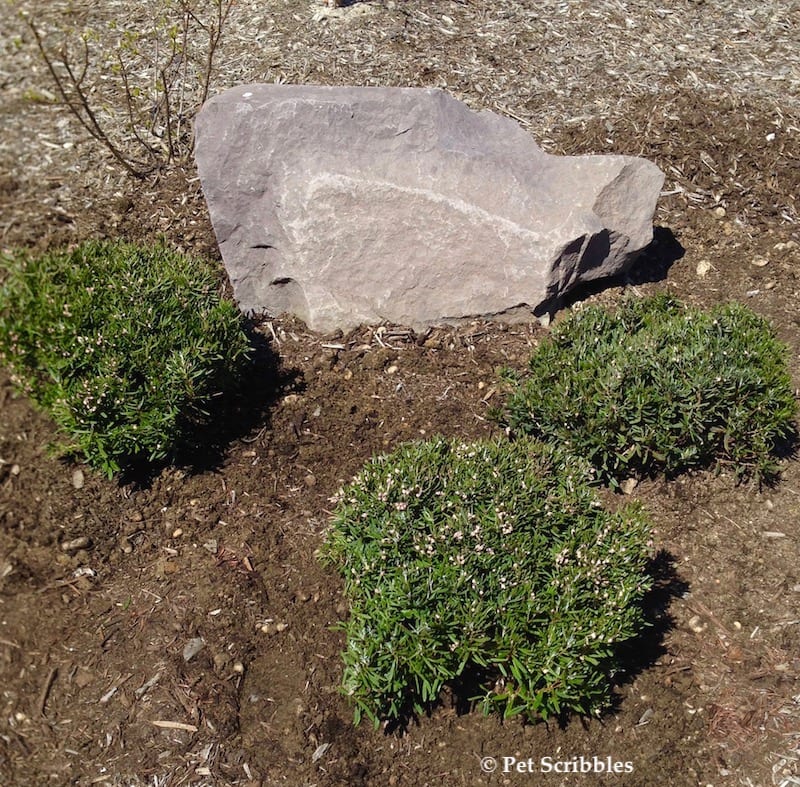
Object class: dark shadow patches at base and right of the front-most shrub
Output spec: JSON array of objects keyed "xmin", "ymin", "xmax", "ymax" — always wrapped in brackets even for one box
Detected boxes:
[{"xmin": 384, "ymin": 550, "xmax": 689, "ymax": 734}]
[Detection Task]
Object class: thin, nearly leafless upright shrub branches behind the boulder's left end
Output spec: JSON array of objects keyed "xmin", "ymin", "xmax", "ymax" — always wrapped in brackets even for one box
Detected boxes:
[{"xmin": 25, "ymin": 0, "xmax": 235, "ymax": 178}]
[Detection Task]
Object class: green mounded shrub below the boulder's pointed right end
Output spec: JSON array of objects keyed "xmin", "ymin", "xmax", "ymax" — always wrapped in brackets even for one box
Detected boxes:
[{"xmin": 500, "ymin": 295, "xmax": 797, "ymax": 485}]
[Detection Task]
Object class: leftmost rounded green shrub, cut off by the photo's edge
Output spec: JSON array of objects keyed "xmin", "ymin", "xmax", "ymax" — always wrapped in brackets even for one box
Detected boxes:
[{"xmin": 0, "ymin": 242, "xmax": 250, "ymax": 476}]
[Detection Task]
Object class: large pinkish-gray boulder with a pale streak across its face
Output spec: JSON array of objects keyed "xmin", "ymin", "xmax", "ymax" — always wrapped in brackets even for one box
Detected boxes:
[{"xmin": 195, "ymin": 85, "xmax": 664, "ymax": 331}]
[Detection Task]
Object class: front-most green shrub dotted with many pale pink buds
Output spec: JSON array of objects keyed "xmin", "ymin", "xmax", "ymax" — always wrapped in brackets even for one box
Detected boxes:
[{"xmin": 322, "ymin": 438, "xmax": 651, "ymax": 724}]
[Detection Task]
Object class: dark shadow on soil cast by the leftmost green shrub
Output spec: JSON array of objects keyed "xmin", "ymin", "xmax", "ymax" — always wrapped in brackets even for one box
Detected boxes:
[{"xmin": 120, "ymin": 322, "xmax": 304, "ymax": 488}]
